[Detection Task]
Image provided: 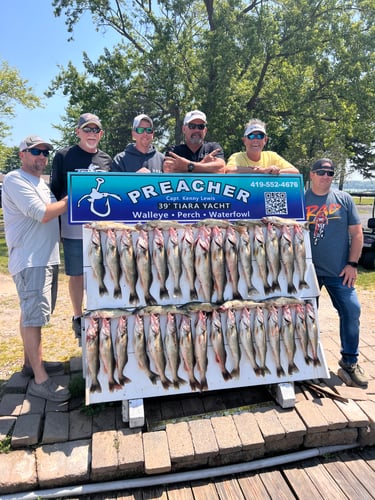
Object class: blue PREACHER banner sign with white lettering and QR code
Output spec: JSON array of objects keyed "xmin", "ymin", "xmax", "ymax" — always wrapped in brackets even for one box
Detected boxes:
[{"xmin": 68, "ymin": 172, "xmax": 305, "ymax": 224}]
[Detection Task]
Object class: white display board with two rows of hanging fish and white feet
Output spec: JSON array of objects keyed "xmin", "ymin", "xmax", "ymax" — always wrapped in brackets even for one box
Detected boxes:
[{"xmin": 82, "ymin": 217, "xmax": 329, "ymax": 427}]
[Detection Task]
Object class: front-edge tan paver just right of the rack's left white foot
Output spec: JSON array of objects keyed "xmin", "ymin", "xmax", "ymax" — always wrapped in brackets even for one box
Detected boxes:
[{"xmin": 143, "ymin": 431, "xmax": 172, "ymax": 474}]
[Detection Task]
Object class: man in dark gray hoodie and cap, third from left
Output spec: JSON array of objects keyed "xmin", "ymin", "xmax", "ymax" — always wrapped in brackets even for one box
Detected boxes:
[{"xmin": 110, "ymin": 114, "xmax": 164, "ymax": 173}]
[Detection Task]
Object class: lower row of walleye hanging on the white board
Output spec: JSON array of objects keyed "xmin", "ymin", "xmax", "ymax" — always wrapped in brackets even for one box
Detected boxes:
[{"xmin": 85, "ymin": 299, "xmax": 321, "ymax": 392}]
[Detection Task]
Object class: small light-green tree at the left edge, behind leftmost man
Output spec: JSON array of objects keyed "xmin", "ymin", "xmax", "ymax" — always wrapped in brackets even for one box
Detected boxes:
[{"xmin": 0, "ymin": 61, "xmax": 41, "ymax": 165}]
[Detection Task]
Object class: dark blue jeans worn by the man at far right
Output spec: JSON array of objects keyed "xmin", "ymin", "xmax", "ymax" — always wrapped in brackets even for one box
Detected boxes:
[{"xmin": 318, "ymin": 276, "xmax": 361, "ymax": 364}]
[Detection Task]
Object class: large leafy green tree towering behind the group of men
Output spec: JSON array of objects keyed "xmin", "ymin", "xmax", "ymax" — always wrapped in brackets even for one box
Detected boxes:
[{"xmin": 50, "ymin": 0, "xmax": 375, "ymax": 177}]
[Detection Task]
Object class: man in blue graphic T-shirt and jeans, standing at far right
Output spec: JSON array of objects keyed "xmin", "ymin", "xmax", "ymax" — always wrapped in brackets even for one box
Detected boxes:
[{"xmin": 305, "ymin": 158, "xmax": 367, "ymax": 387}]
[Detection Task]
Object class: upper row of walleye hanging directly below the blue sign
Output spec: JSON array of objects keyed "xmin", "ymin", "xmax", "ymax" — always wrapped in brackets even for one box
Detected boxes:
[{"xmin": 88, "ymin": 218, "xmax": 309, "ymax": 305}]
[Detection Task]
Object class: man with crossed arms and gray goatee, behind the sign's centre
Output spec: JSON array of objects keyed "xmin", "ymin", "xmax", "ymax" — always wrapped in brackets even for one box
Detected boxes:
[{"xmin": 164, "ymin": 109, "xmax": 225, "ymax": 174}]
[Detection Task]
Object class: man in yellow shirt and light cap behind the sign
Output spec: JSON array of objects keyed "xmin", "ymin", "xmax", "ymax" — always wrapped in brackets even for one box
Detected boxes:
[{"xmin": 225, "ymin": 119, "xmax": 299, "ymax": 175}]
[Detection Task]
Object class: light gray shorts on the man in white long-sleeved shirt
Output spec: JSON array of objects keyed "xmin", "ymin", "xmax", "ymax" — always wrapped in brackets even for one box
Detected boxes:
[{"xmin": 13, "ymin": 265, "xmax": 59, "ymax": 327}]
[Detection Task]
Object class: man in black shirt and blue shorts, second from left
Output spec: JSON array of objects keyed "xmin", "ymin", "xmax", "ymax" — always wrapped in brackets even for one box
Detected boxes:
[{"xmin": 51, "ymin": 113, "xmax": 112, "ymax": 342}]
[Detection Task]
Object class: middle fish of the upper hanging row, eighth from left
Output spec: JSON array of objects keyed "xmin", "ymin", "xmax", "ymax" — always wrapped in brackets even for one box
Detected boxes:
[{"xmin": 194, "ymin": 226, "xmax": 212, "ymax": 302}]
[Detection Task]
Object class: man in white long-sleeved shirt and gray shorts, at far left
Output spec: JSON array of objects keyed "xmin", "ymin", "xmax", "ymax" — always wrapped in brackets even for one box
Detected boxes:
[{"xmin": 2, "ymin": 135, "xmax": 70, "ymax": 402}]
